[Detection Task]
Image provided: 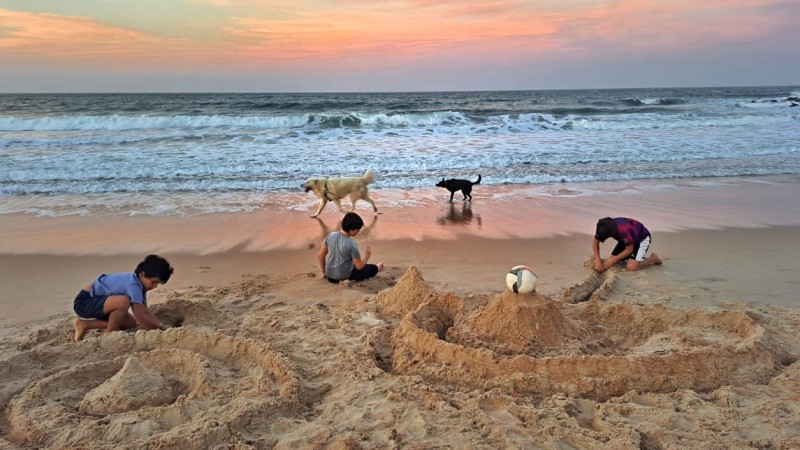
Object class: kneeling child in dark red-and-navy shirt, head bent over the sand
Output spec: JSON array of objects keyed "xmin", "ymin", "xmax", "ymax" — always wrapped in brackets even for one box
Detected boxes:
[{"xmin": 592, "ymin": 217, "xmax": 661, "ymax": 272}]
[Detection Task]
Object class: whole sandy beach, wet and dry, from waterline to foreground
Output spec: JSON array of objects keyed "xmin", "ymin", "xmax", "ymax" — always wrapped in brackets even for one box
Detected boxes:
[{"xmin": 0, "ymin": 177, "xmax": 800, "ymax": 449}]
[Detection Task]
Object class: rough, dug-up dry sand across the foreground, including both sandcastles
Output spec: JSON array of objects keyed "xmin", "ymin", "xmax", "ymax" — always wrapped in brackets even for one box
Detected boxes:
[{"xmin": 0, "ymin": 267, "xmax": 800, "ymax": 449}]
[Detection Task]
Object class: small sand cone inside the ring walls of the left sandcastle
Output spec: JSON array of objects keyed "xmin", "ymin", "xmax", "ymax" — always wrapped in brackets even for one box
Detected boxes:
[{"xmin": 78, "ymin": 356, "xmax": 175, "ymax": 415}]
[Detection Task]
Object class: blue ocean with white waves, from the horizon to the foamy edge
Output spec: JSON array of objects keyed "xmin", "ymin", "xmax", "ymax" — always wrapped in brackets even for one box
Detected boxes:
[{"xmin": 0, "ymin": 86, "xmax": 800, "ymax": 216}]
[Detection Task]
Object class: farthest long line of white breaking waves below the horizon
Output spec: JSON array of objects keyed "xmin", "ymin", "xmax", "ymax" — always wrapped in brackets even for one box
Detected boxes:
[{"xmin": 0, "ymin": 108, "xmax": 797, "ymax": 132}]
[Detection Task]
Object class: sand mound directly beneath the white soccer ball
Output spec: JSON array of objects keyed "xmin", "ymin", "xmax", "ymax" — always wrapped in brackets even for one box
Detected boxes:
[{"xmin": 446, "ymin": 290, "xmax": 582, "ymax": 356}]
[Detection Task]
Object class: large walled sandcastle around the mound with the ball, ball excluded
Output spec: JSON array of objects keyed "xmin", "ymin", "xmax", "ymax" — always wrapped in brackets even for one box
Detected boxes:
[{"xmin": 377, "ymin": 269, "xmax": 780, "ymax": 400}]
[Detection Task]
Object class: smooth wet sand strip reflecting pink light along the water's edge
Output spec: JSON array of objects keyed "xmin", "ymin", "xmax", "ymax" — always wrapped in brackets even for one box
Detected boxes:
[{"xmin": 0, "ymin": 175, "xmax": 800, "ymax": 255}]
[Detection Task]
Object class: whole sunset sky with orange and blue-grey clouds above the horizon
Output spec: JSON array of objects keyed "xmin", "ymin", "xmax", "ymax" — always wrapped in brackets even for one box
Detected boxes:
[{"xmin": 0, "ymin": 0, "xmax": 800, "ymax": 93}]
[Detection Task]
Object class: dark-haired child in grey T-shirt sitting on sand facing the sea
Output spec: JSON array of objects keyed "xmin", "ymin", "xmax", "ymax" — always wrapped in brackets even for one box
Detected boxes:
[{"xmin": 317, "ymin": 212, "xmax": 383, "ymax": 283}]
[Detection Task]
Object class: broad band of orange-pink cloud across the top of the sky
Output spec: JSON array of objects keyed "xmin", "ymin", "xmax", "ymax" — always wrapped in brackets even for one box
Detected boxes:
[{"xmin": 0, "ymin": 0, "xmax": 788, "ymax": 73}]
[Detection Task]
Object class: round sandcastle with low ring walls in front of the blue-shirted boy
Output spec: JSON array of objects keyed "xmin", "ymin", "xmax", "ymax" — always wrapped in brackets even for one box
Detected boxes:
[{"xmin": 7, "ymin": 328, "xmax": 300, "ymax": 448}]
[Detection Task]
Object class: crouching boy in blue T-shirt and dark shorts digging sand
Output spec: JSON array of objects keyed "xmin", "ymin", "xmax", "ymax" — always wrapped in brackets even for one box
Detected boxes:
[{"xmin": 72, "ymin": 255, "xmax": 173, "ymax": 342}]
